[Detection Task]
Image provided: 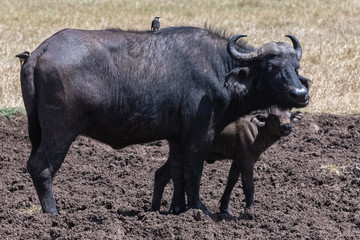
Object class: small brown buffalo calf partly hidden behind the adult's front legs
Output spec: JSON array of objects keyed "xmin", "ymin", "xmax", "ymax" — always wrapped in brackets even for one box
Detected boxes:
[{"xmin": 152, "ymin": 107, "xmax": 303, "ymax": 218}]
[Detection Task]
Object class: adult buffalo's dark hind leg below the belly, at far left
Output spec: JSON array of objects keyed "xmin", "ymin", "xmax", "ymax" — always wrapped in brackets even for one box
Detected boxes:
[{"xmin": 27, "ymin": 135, "xmax": 75, "ymax": 214}]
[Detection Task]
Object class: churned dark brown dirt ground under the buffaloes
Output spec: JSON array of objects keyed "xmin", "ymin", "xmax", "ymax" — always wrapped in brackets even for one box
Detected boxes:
[{"xmin": 0, "ymin": 114, "xmax": 360, "ymax": 239}]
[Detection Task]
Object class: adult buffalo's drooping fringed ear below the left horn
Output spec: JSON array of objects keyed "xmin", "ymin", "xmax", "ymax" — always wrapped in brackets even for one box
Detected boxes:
[{"xmin": 225, "ymin": 67, "xmax": 253, "ymax": 96}]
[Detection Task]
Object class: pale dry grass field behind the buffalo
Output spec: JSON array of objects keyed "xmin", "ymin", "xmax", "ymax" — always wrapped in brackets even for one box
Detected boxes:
[{"xmin": 0, "ymin": 0, "xmax": 360, "ymax": 114}]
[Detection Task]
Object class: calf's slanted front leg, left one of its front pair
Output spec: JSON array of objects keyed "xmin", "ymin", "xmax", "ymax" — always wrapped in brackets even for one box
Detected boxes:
[{"xmin": 220, "ymin": 160, "xmax": 240, "ymax": 215}]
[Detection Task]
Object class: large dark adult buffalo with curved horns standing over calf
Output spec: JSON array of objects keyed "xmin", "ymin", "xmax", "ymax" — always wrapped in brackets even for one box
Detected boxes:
[{"xmin": 21, "ymin": 27, "xmax": 309, "ymax": 213}]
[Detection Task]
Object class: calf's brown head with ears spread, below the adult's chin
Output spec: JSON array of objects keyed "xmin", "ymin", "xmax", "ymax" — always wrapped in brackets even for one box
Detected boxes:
[{"xmin": 251, "ymin": 107, "xmax": 304, "ymax": 137}]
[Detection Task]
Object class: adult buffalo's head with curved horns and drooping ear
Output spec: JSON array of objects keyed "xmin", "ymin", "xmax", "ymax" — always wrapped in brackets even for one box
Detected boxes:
[{"xmin": 225, "ymin": 35, "xmax": 310, "ymax": 109}]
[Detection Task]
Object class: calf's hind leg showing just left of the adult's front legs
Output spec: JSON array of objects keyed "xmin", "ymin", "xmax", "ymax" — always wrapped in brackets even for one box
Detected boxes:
[{"xmin": 151, "ymin": 158, "xmax": 171, "ymax": 211}]
